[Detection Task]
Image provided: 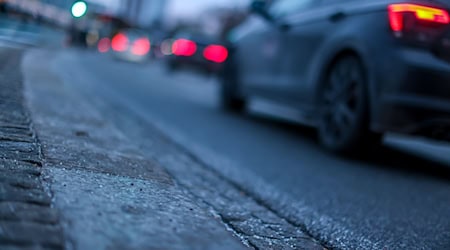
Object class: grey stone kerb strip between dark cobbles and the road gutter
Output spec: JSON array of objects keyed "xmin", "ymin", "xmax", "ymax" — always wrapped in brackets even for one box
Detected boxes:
[{"xmin": 22, "ymin": 47, "xmax": 245, "ymax": 249}]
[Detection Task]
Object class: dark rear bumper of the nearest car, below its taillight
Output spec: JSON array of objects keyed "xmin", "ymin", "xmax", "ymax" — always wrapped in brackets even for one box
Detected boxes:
[{"xmin": 377, "ymin": 47, "xmax": 450, "ymax": 141}]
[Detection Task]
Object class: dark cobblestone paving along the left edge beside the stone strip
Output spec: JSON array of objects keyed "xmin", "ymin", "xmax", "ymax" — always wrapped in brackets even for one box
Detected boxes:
[{"xmin": 0, "ymin": 50, "xmax": 64, "ymax": 249}]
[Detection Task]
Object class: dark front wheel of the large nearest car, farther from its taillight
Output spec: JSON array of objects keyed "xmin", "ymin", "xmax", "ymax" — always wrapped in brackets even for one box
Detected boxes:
[{"xmin": 219, "ymin": 57, "xmax": 247, "ymax": 113}]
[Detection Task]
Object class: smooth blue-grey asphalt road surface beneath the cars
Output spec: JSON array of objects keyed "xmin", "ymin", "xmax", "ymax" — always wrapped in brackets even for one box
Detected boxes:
[{"xmin": 54, "ymin": 51, "xmax": 450, "ymax": 249}]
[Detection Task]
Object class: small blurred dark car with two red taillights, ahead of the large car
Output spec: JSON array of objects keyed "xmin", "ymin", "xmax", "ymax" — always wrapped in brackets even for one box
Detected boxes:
[{"xmin": 163, "ymin": 32, "xmax": 228, "ymax": 73}]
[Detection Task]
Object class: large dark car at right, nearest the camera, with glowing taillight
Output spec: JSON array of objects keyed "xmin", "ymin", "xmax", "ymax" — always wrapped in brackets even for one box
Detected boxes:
[{"xmin": 220, "ymin": 0, "xmax": 450, "ymax": 153}]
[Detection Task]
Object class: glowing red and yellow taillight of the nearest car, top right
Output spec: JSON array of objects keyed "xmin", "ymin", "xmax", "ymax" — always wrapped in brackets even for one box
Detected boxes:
[{"xmin": 388, "ymin": 3, "xmax": 450, "ymax": 32}]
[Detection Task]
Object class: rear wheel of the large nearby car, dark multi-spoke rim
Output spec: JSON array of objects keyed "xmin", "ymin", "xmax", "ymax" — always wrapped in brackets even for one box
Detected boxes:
[{"xmin": 318, "ymin": 55, "xmax": 381, "ymax": 155}]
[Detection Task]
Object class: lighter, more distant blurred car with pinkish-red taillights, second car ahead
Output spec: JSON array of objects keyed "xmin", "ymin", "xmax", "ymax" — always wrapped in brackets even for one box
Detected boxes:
[{"xmin": 110, "ymin": 29, "xmax": 151, "ymax": 62}]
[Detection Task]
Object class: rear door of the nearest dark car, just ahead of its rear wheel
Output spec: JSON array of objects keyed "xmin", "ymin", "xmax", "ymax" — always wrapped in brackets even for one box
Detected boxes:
[{"xmin": 279, "ymin": 0, "xmax": 358, "ymax": 108}]
